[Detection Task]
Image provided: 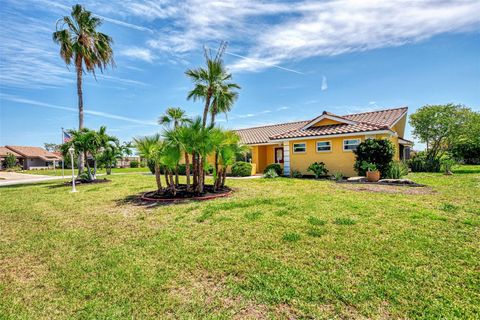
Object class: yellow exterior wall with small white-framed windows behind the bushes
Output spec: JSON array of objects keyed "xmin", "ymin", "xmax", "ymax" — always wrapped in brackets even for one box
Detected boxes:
[{"xmin": 288, "ymin": 135, "xmax": 399, "ymax": 177}]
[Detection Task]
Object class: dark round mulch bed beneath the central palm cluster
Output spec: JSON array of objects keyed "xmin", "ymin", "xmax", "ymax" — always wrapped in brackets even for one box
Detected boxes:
[{"xmin": 140, "ymin": 184, "xmax": 232, "ymax": 203}]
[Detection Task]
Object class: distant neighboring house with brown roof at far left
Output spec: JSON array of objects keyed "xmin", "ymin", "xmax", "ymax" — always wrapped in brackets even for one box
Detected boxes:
[{"xmin": 0, "ymin": 146, "xmax": 62, "ymax": 170}]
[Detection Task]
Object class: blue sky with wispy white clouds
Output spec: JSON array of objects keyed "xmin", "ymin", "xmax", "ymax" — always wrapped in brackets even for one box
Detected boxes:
[{"xmin": 0, "ymin": 0, "xmax": 480, "ymax": 148}]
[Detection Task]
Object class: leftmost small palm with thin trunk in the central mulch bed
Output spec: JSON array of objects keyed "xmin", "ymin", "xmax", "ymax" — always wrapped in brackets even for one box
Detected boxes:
[{"xmin": 133, "ymin": 134, "xmax": 164, "ymax": 193}]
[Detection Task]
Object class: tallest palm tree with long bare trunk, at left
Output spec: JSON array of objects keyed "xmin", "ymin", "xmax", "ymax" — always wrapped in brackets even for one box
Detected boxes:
[{"xmin": 53, "ymin": 4, "xmax": 114, "ymax": 173}]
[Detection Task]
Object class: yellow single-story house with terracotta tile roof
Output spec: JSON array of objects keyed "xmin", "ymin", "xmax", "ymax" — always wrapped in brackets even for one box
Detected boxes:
[{"xmin": 236, "ymin": 107, "xmax": 412, "ymax": 176}]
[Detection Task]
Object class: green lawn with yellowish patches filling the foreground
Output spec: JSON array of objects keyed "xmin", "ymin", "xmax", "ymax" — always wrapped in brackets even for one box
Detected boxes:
[{"xmin": 0, "ymin": 166, "xmax": 480, "ymax": 319}]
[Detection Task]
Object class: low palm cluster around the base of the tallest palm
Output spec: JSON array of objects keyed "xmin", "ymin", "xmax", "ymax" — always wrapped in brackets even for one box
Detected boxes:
[{"xmin": 61, "ymin": 126, "xmax": 130, "ymax": 181}]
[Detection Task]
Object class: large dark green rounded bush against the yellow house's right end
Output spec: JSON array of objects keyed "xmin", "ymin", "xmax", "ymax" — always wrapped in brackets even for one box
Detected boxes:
[{"xmin": 353, "ymin": 139, "xmax": 395, "ymax": 178}]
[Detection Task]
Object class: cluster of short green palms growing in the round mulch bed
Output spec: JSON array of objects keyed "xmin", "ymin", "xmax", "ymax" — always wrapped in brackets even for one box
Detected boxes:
[{"xmin": 134, "ymin": 108, "xmax": 248, "ymax": 196}]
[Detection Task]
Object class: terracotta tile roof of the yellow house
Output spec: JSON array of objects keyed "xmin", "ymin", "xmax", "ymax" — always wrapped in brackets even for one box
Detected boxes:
[{"xmin": 237, "ymin": 107, "xmax": 408, "ymax": 144}]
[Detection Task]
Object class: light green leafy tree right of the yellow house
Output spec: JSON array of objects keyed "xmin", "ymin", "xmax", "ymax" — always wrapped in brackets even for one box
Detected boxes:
[{"xmin": 410, "ymin": 103, "xmax": 470, "ymax": 162}]
